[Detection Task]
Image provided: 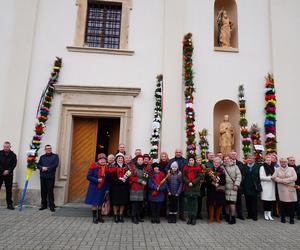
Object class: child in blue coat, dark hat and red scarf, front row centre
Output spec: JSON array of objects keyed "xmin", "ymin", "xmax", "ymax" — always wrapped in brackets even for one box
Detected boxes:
[{"xmin": 148, "ymin": 163, "xmax": 167, "ymax": 223}]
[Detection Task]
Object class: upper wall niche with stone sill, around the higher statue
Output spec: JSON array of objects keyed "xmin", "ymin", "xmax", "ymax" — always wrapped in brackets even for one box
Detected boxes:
[{"xmin": 214, "ymin": 0, "xmax": 238, "ymax": 52}]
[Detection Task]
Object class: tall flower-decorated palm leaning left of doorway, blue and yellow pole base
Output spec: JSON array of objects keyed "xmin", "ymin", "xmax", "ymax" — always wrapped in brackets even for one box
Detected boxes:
[{"xmin": 20, "ymin": 57, "xmax": 62, "ymax": 211}]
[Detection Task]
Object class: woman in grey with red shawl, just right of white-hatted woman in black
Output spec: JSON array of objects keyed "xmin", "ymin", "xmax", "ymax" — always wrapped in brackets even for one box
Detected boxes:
[{"xmin": 129, "ymin": 155, "xmax": 147, "ymax": 224}]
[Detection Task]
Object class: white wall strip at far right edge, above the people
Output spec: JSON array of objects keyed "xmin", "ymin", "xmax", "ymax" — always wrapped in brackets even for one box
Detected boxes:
[{"xmin": 270, "ymin": 0, "xmax": 300, "ymax": 160}]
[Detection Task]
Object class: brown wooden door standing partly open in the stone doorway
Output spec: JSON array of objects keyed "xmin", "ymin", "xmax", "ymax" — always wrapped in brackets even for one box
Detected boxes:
[{"xmin": 68, "ymin": 117, "xmax": 120, "ymax": 202}]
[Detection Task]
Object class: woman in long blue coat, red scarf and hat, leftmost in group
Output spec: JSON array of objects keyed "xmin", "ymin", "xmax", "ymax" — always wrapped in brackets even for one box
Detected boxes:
[{"xmin": 85, "ymin": 154, "xmax": 109, "ymax": 224}]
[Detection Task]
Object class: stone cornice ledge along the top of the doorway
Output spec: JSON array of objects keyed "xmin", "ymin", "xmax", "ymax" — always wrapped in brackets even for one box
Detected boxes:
[{"xmin": 54, "ymin": 84, "xmax": 141, "ymax": 97}]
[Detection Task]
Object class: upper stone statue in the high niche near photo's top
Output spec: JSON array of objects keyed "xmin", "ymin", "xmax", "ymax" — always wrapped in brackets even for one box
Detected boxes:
[{"xmin": 217, "ymin": 9, "xmax": 233, "ymax": 48}]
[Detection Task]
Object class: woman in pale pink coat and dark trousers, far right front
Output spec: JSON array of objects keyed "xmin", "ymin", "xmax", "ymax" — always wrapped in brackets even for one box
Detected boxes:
[{"xmin": 272, "ymin": 158, "xmax": 297, "ymax": 224}]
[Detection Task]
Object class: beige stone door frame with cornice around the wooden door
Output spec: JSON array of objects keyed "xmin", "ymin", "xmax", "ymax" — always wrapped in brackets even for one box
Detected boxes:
[{"xmin": 54, "ymin": 85, "xmax": 140, "ymax": 205}]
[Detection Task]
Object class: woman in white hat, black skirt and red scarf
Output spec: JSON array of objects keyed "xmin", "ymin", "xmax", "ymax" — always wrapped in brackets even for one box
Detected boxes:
[{"xmin": 110, "ymin": 153, "xmax": 129, "ymax": 223}]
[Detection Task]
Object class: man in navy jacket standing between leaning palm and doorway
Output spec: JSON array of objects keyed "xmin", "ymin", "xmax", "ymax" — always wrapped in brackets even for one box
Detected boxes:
[{"xmin": 37, "ymin": 145, "xmax": 59, "ymax": 212}]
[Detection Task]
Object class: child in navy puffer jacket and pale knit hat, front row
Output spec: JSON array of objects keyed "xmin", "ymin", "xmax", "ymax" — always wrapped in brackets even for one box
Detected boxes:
[{"xmin": 167, "ymin": 161, "xmax": 182, "ymax": 223}]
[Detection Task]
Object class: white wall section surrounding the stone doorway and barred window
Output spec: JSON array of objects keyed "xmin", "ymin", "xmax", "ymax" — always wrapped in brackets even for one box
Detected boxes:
[{"xmin": 18, "ymin": 0, "xmax": 163, "ymax": 189}]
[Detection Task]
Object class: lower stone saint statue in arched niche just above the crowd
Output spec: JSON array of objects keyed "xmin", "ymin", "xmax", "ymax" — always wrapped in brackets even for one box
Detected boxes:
[{"xmin": 219, "ymin": 115, "xmax": 234, "ymax": 155}]
